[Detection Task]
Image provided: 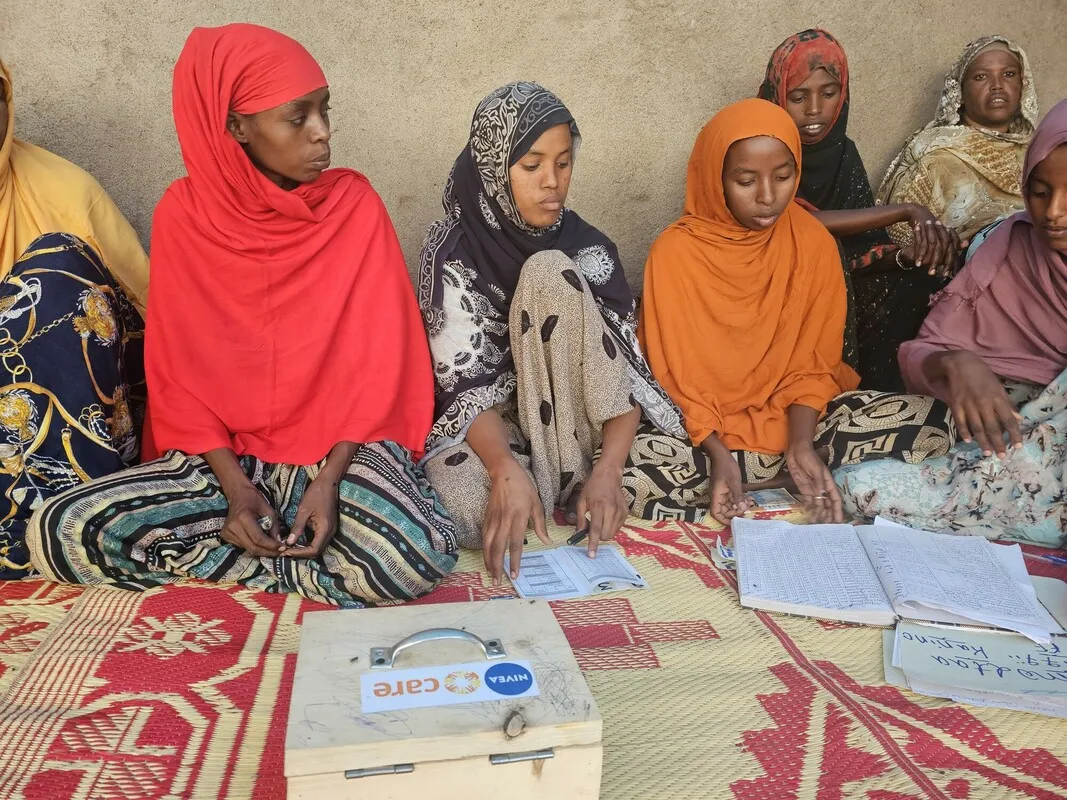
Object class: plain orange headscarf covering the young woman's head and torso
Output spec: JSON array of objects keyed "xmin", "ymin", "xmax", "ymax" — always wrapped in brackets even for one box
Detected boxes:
[{"xmin": 640, "ymin": 99, "xmax": 859, "ymax": 453}]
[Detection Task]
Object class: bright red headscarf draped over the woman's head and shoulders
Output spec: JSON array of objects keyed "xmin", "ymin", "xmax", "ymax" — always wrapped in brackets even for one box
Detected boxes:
[{"xmin": 144, "ymin": 25, "xmax": 433, "ymax": 464}]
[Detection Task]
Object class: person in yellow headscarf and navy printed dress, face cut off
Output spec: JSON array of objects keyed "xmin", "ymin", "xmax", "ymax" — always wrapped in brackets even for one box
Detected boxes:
[{"xmin": 0, "ymin": 63, "xmax": 148, "ymax": 579}]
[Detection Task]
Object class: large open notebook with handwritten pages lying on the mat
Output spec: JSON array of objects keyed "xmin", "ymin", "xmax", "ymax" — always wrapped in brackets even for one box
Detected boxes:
[{"xmin": 732, "ymin": 518, "xmax": 1064, "ymax": 642}]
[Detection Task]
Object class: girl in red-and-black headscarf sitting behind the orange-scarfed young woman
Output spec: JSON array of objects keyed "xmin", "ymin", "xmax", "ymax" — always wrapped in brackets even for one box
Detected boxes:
[{"xmin": 760, "ymin": 29, "xmax": 959, "ymax": 390}]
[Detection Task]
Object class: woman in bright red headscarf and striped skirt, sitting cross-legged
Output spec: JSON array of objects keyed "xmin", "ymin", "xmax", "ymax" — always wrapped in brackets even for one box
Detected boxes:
[{"xmin": 28, "ymin": 25, "xmax": 456, "ymax": 606}]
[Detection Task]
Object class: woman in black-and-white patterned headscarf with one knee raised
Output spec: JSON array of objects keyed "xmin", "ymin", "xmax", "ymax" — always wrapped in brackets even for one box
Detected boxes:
[{"xmin": 418, "ymin": 82, "xmax": 685, "ymax": 578}]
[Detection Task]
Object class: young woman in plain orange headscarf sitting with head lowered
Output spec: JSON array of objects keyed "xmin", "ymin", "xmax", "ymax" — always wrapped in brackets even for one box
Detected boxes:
[{"xmin": 635, "ymin": 99, "xmax": 950, "ymax": 522}]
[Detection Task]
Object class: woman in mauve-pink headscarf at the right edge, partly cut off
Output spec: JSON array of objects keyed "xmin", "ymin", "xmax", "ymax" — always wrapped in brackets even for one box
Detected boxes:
[{"xmin": 834, "ymin": 95, "xmax": 1067, "ymax": 547}]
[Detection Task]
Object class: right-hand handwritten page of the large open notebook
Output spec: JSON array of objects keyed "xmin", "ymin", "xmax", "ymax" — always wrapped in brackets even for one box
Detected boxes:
[{"xmin": 856, "ymin": 526, "xmax": 1063, "ymax": 641}]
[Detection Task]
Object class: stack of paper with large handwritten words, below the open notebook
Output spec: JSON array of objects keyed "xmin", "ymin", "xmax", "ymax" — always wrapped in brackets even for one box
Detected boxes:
[{"xmin": 883, "ymin": 622, "xmax": 1067, "ymax": 719}]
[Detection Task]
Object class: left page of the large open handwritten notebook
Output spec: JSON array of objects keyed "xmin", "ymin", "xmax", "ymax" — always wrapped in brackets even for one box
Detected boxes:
[{"xmin": 731, "ymin": 517, "xmax": 892, "ymax": 612}]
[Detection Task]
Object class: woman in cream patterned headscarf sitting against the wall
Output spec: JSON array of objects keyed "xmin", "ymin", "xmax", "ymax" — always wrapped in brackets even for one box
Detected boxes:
[{"xmin": 878, "ymin": 36, "xmax": 1038, "ymax": 243}]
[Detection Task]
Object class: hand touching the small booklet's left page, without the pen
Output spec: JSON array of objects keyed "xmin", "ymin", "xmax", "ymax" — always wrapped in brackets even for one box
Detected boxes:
[{"xmin": 481, "ymin": 459, "xmax": 552, "ymax": 586}]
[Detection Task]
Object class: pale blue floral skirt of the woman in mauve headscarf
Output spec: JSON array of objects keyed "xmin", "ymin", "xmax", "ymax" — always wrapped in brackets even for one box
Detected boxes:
[{"xmin": 833, "ymin": 371, "xmax": 1067, "ymax": 547}]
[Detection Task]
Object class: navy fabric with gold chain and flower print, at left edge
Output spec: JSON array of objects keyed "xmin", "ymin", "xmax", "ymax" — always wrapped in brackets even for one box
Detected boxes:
[{"xmin": 0, "ymin": 234, "xmax": 144, "ymax": 579}]
